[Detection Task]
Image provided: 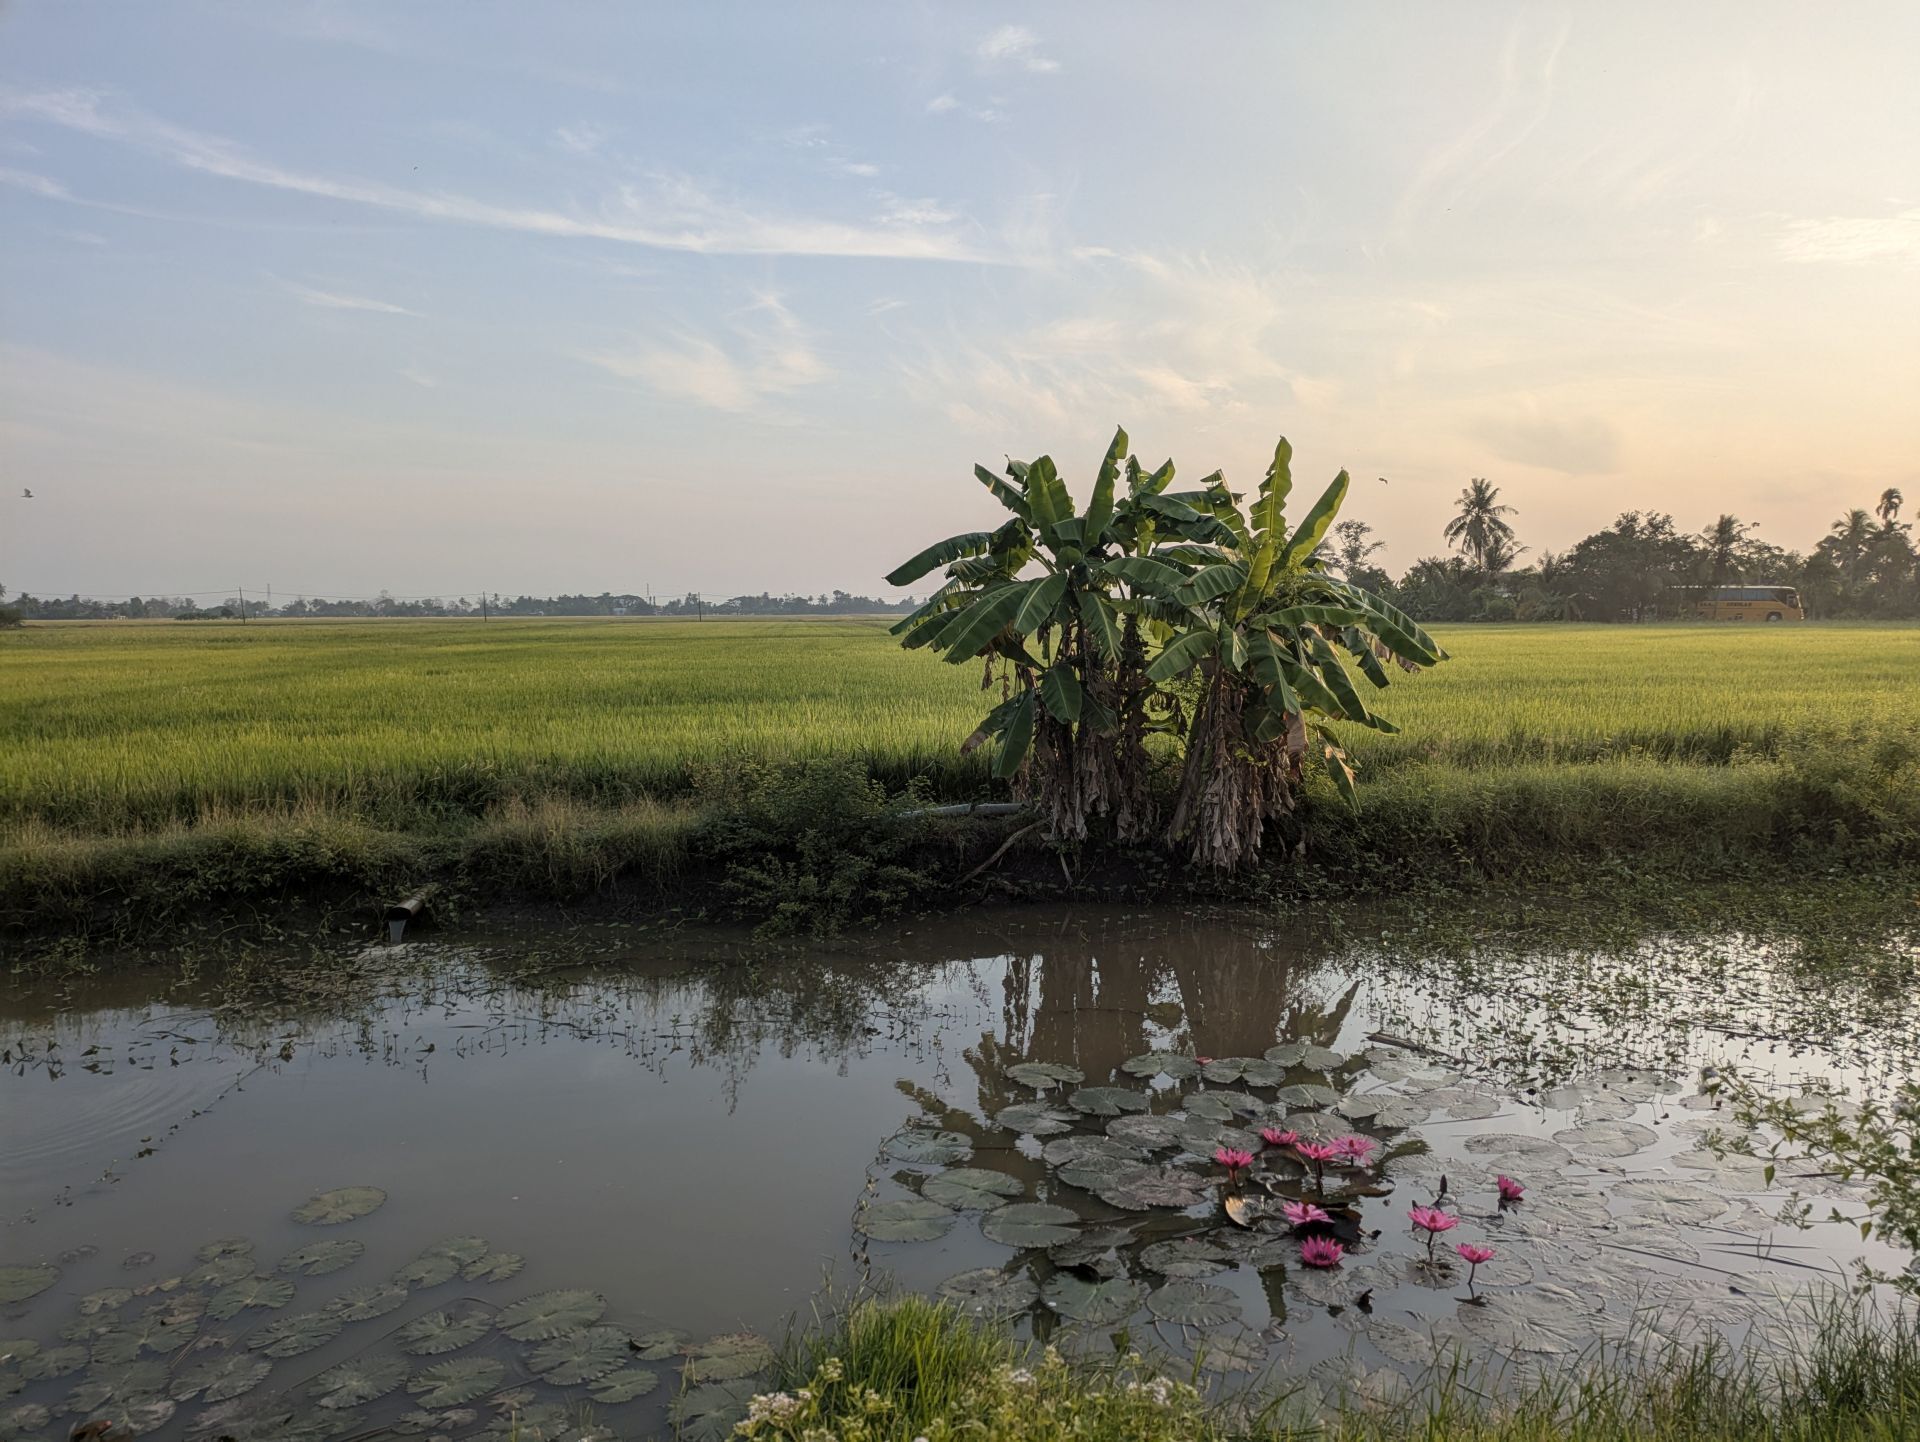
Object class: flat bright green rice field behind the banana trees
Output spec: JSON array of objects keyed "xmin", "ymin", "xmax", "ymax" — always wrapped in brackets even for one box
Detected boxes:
[{"xmin": 0, "ymin": 618, "xmax": 1920, "ymax": 831}]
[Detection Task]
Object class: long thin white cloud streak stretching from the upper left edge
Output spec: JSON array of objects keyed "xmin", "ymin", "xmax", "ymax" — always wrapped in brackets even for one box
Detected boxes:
[{"xmin": 0, "ymin": 90, "xmax": 1008, "ymax": 263}]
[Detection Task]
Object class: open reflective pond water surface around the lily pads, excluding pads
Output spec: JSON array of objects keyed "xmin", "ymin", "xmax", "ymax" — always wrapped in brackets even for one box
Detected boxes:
[{"xmin": 0, "ymin": 910, "xmax": 1912, "ymax": 1434}]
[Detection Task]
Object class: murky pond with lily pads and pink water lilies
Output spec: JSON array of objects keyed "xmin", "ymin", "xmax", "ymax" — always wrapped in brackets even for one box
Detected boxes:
[{"xmin": 0, "ymin": 908, "xmax": 1920, "ymax": 1442}]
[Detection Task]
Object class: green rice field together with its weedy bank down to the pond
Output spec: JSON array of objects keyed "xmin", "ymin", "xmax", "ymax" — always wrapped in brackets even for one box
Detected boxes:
[{"xmin": 0, "ymin": 622, "xmax": 1920, "ymax": 937}]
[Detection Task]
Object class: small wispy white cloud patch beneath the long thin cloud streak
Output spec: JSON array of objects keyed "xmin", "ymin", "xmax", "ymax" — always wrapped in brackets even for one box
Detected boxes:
[{"xmin": 582, "ymin": 292, "xmax": 831, "ymax": 413}]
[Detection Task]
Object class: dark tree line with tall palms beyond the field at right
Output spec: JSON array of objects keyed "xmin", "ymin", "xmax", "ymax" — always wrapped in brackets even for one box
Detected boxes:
[{"xmin": 1321, "ymin": 478, "xmax": 1920, "ymax": 620}]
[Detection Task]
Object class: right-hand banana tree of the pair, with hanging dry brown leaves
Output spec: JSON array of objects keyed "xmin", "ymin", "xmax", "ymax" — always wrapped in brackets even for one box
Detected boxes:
[{"xmin": 1133, "ymin": 438, "xmax": 1444, "ymax": 868}]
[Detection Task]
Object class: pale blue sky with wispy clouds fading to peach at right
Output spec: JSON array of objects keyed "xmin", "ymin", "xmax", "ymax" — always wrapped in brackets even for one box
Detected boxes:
[{"xmin": 0, "ymin": 0, "xmax": 1920, "ymax": 599}]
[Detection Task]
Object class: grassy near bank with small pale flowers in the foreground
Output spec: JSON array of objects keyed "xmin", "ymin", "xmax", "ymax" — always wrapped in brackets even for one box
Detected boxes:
[{"xmin": 747, "ymin": 1298, "xmax": 1920, "ymax": 1442}]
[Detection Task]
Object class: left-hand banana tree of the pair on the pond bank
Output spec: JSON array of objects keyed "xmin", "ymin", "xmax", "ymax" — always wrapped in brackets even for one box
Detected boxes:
[{"xmin": 887, "ymin": 430, "xmax": 1208, "ymax": 841}]
